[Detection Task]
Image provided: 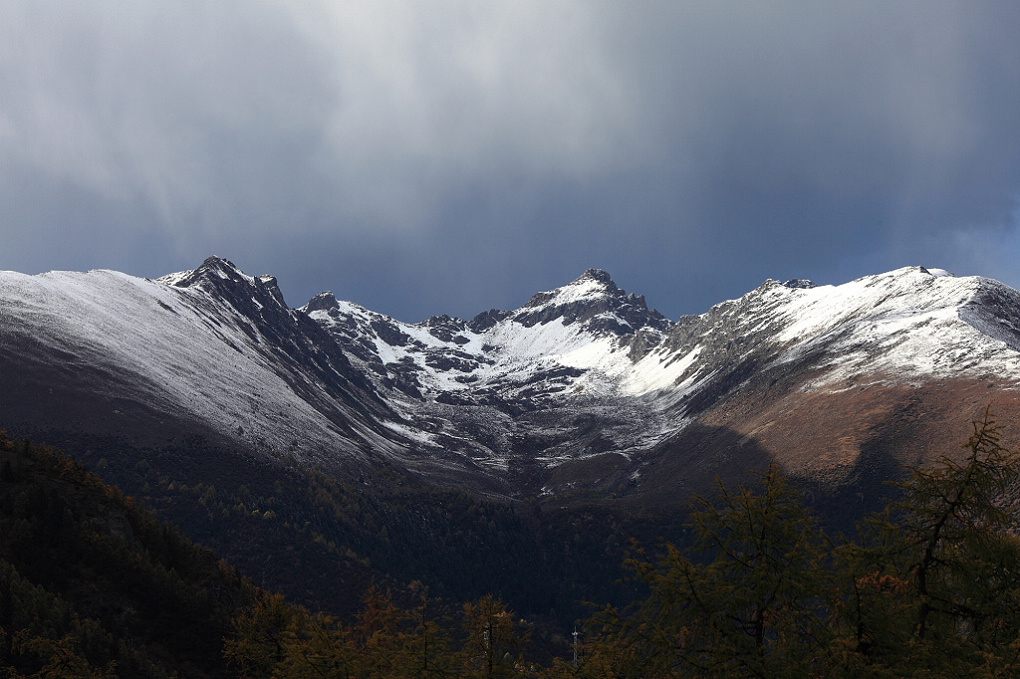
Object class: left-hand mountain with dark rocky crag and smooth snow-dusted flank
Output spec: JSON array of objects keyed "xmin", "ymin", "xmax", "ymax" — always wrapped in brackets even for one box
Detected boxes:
[{"xmin": 0, "ymin": 258, "xmax": 401, "ymax": 464}]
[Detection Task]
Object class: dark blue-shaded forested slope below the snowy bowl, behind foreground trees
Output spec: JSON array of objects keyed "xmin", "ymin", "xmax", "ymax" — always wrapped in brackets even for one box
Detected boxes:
[{"xmin": 60, "ymin": 428, "xmax": 660, "ymax": 630}]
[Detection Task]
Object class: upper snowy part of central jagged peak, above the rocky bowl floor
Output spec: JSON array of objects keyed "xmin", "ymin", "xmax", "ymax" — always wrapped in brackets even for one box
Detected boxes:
[{"xmin": 302, "ymin": 270, "xmax": 681, "ymax": 398}]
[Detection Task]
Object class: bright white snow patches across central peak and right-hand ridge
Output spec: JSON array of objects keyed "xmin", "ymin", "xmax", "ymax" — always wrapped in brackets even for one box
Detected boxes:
[{"xmin": 309, "ymin": 267, "xmax": 1020, "ymax": 411}]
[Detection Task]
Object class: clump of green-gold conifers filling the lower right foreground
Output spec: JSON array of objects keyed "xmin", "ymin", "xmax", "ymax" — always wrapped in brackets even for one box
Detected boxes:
[{"xmin": 566, "ymin": 413, "xmax": 1020, "ymax": 677}]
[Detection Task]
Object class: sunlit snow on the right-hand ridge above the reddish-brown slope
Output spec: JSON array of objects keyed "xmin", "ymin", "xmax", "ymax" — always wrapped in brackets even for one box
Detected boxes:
[{"xmin": 628, "ymin": 267, "xmax": 1020, "ymax": 403}]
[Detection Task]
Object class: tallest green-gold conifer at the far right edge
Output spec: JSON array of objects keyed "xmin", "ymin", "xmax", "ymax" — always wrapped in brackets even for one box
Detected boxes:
[{"xmin": 835, "ymin": 403, "xmax": 1020, "ymax": 677}]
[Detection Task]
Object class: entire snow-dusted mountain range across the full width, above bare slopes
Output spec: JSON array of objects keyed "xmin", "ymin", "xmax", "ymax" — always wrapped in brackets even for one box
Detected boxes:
[{"xmin": 0, "ymin": 258, "xmax": 1020, "ymax": 479}]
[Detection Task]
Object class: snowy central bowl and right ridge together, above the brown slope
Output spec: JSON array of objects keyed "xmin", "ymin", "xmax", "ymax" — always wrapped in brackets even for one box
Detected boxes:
[{"xmin": 305, "ymin": 260, "xmax": 1020, "ymax": 479}]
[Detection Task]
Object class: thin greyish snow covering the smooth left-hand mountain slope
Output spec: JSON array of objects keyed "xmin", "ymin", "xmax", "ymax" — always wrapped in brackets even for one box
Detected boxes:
[{"xmin": 0, "ymin": 259, "xmax": 392, "ymax": 462}]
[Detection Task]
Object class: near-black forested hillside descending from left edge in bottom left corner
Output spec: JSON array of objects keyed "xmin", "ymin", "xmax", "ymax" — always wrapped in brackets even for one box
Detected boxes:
[{"xmin": 0, "ymin": 432, "xmax": 258, "ymax": 679}]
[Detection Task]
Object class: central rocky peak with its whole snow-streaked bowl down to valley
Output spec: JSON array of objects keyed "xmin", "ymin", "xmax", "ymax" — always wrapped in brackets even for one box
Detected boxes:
[{"xmin": 302, "ymin": 269, "xmax": 685, "ymax": 471}]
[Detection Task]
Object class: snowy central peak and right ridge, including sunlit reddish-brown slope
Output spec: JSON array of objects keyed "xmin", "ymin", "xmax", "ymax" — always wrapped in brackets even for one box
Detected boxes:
[{"xmin": 303, "ymin": 260, "xmax": 1020, "ymax": 492}]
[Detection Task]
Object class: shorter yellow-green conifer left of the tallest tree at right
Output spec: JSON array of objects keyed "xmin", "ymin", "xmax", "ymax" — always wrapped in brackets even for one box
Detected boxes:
[{"xmin": 579, "ymin": 465, "xmax": 830, "ymax": 677}]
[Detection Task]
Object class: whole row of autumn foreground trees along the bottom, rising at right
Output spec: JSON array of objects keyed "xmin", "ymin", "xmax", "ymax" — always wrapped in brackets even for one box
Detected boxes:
[{"xmin": 225, "ymin": 413, "xmax": 1020, "ymax": 679}]
